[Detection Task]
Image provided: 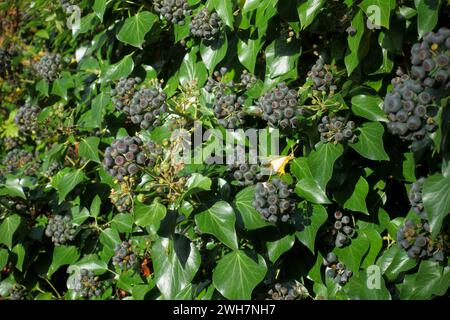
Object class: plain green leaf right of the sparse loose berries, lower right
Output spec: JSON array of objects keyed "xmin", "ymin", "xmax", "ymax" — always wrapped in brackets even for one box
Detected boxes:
[{"xmin": 333, "ymin": 233, "xmax": 370, "ymax": 273}]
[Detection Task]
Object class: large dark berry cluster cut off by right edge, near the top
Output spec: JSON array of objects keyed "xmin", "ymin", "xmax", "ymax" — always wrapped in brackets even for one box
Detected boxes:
[{"xmin": 411, "ymin": 28, "xmax": 450, "ymax": 93}]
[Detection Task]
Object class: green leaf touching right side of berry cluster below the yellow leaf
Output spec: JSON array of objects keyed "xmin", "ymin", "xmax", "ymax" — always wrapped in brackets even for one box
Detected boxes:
[{"xmin": 295, "ymin": 204, "xmax": 328, "ymax": 254}]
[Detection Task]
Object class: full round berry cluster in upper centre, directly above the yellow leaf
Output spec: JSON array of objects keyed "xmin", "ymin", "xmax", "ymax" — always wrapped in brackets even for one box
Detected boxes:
[{"xmin": 258, "ymin": 82, "xmax": 298, "ymax": 129}]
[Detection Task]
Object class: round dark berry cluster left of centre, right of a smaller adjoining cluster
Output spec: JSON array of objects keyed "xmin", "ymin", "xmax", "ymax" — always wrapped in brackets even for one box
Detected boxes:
[{"xmin": 125, "ymin": 85, "xmax": 167, "ymax": 130}]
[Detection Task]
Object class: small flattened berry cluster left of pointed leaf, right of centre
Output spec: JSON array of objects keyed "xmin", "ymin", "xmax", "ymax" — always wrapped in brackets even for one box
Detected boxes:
[{"xmin": 318, "ymin": 115, "xmax": 358, "ymax": 143}]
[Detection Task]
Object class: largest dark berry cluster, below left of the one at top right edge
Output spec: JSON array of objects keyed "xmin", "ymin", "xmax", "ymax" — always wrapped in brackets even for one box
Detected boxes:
[{"xmin": 383, "ymin": 75, "xmax": 436, "ymax": 140}]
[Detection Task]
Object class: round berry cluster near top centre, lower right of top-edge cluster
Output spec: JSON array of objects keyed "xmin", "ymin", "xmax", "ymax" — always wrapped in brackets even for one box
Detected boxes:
[{"xmin": 189, "ymin": 7, "xmax": 223, "ymax": 40}]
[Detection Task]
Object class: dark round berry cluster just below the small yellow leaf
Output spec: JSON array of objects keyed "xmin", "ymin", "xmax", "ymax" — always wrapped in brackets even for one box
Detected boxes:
[{"xmin": 253, "ymin": 178, "xmax": 296, "ymax": 223}]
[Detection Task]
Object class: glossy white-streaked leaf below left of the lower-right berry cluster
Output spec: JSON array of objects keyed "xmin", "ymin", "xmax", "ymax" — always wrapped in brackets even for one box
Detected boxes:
[{"xmin": 377, "ymin": 245, "xmax": 417, "ymax": 280}]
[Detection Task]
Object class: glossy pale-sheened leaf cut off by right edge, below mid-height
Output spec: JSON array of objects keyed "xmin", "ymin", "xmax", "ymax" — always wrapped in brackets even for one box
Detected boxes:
[{"xmin": 422, "ymin": 173, "xmax": 450, "ymax": 238}]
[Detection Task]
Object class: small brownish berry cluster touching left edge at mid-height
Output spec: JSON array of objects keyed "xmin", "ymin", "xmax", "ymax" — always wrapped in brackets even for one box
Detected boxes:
[{"xmin": 0, "ymin": 149, "xmax": 39, "ymax": 176}]
